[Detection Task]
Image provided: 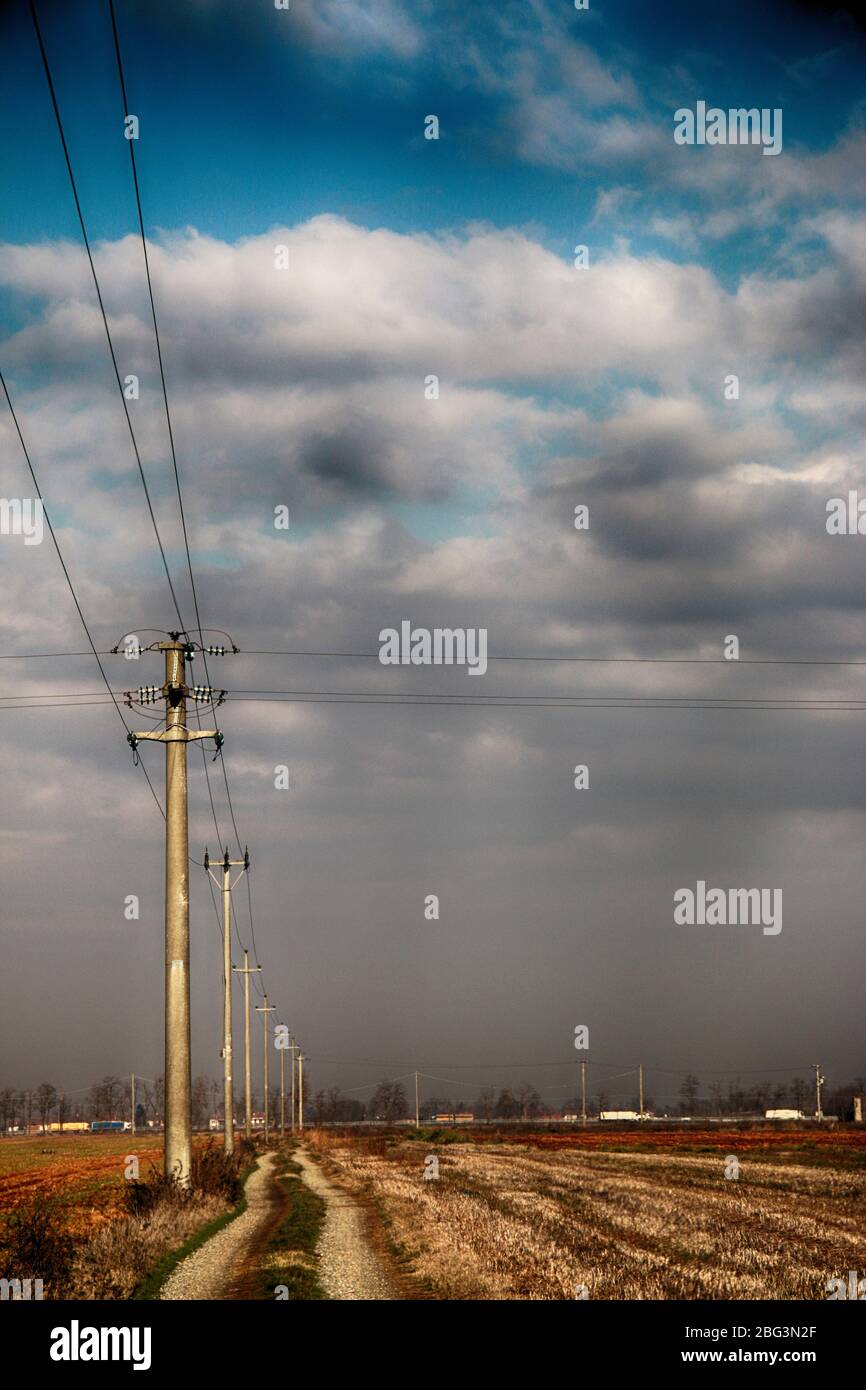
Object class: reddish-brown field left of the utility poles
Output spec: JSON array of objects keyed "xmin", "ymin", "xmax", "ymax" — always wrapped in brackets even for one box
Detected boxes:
[{"xmin": 0, "ymin": 1134, "xmax": 163, "ymax": 1236}]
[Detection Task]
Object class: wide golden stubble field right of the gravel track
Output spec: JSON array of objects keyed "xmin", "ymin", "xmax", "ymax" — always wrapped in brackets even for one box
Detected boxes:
[{"xmin": 310, "ymin": 1129, "xmax": 866, "ymax": 1300}]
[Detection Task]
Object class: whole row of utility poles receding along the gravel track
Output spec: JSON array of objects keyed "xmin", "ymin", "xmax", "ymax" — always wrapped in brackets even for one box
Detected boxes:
[{"xmin": 114, "ymin": 632, "xmax": 304, "ymax": 1187}]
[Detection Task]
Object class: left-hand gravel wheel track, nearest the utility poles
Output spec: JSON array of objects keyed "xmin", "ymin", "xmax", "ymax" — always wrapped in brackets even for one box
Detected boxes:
[{"xmin": 160, "ymin": 1154, "xmax": 277, "ymax": 1300}]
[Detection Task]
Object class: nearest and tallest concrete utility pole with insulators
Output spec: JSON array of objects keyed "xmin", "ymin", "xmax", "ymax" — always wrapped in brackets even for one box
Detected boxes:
[{"xmin": 124, "ymin": 632, "xmax": 230, "ymax": 1187}]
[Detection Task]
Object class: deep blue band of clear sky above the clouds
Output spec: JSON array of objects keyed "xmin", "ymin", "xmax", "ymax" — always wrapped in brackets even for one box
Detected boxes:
[{"xmin": 0, "ymin": 0, "xmax": 863, "ymax": 265}]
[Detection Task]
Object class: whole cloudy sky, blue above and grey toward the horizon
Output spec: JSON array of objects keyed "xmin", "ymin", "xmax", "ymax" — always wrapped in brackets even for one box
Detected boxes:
[{"xmin": 0, "ymin": 0, "xmax": 866, "ymax": 1106}]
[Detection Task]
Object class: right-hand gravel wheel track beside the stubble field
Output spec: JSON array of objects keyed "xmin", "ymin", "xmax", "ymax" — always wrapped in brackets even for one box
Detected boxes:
[{"xmin": 292, "ymin": 1148, "xmax": 398, "ymax": 1302}]
